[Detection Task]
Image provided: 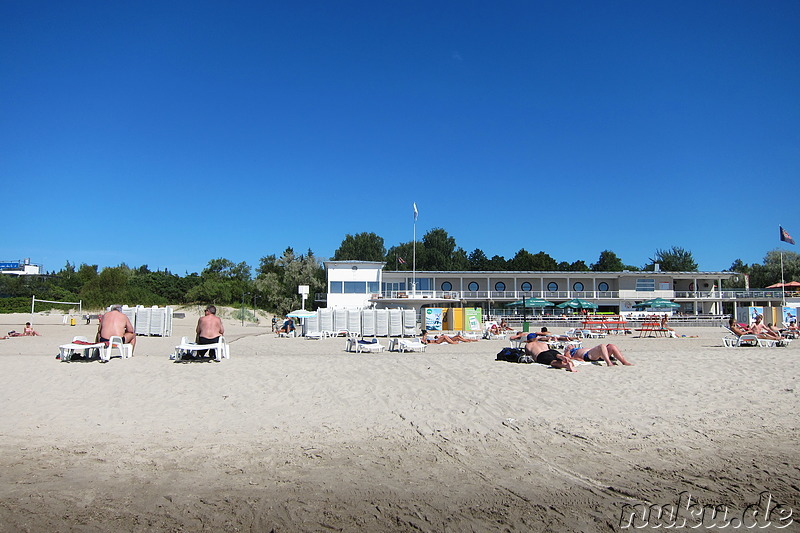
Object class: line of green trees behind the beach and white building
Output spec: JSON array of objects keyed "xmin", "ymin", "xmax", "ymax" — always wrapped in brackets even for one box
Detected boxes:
[{"xmin": 0, "ymin": 228, "xmax": 800, "ymax": 314}]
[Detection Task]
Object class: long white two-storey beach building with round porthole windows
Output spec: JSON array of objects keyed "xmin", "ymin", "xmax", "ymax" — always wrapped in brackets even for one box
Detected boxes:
[{"xmin": 316, "ymin": 261, "xmax": 800, "ymax": 316}]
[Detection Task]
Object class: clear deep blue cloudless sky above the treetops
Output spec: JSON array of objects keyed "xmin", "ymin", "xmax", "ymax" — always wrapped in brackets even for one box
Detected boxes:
[{"xmin": 0, "ymin": 0, "xmax": 800, "ymax": 274}]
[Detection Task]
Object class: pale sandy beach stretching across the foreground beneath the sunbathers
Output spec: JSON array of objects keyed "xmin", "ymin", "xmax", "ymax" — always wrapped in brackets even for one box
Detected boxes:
[{"xmin": 0, "ymin": 314, "xmax": 800, "ymax": 532}]
